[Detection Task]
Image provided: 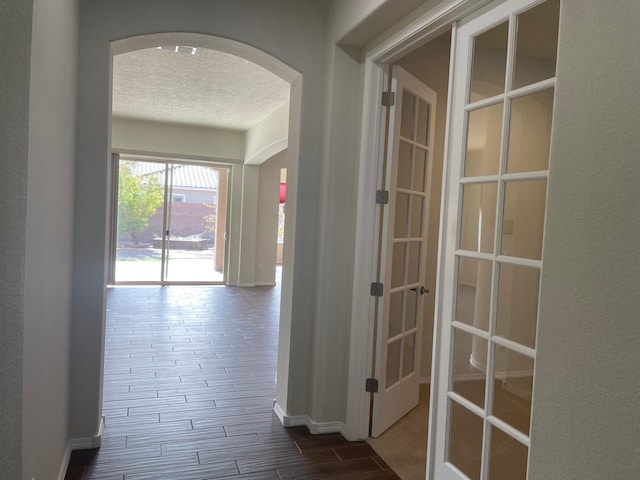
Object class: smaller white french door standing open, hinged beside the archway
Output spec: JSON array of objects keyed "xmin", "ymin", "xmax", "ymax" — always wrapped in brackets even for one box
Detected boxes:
[{"xmin": 371, "ymin": 66, "xmax": 436, "ymax": 437}]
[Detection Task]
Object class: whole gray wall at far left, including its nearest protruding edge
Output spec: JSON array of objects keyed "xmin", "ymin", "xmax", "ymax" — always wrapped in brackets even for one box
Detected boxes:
[{"xmin": 0, "ymin": 0, "xmax": 77, "ymax": 479}]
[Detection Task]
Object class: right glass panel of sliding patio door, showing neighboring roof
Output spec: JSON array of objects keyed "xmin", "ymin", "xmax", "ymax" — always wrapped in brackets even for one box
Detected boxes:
[{"xmin": 166, "ymin": 164, "xmax": 227, "ymax": 282}]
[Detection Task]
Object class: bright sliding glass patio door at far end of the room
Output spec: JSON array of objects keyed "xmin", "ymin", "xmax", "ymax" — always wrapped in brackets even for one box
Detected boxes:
[{"xmin": 111, "ymin": 155, "xmax": 229, "ymax": 284}]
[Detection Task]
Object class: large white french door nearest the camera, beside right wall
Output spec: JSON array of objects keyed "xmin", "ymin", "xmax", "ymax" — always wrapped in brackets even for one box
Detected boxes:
[{"xmin": 428, "ymin": 0, "xmax": 559, "ymax": 480}]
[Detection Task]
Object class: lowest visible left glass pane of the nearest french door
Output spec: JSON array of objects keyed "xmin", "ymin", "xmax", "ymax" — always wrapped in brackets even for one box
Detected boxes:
[{"xmin": 448, "ymin": 400, "xmax": 483, "ymax": 480}]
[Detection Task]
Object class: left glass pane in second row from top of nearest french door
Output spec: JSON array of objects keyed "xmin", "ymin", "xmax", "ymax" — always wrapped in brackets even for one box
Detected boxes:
[{"xmin": 464, "ymin": 102, "xmax": 503, "ymax": 177}]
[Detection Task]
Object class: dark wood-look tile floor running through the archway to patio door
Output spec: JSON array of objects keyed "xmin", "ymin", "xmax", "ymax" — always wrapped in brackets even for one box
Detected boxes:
[{"xmin": 66, "ymin": 286, "xmax": 399, "ymax": 480}]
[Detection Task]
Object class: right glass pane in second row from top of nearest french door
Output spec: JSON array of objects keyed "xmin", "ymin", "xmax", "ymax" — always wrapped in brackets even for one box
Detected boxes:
[{"xmin": 507, "ymin": 88, "xmax": 553, "ymax": 173}]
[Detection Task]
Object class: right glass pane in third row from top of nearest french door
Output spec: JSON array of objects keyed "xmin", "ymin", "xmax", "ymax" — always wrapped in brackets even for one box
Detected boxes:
[{"xmin": 500, "ymin": 180, "xmax": 547, "ymax": 260}]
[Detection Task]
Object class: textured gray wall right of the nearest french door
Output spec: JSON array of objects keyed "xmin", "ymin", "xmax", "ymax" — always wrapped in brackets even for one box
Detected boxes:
[{"xmin": 529, "ymin": 0, "xmax": 640, "ymax": 480}]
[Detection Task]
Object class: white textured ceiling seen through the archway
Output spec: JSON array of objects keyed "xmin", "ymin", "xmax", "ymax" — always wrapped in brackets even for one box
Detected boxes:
[{"xmin": 113, "ymin": 47, "xmax": 289, "ymax": 130}]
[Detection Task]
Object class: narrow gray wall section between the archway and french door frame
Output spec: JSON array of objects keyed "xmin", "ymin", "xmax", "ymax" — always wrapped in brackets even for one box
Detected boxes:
[{"xmin": 309, "ymin": 45, "xmax": 366, "ymax": 422}]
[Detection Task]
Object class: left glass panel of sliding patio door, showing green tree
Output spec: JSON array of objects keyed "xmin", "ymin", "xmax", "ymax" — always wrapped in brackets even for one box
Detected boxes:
[{"xmin": 115, "ymin": 160, "xmax": 165, "ymax": 283}]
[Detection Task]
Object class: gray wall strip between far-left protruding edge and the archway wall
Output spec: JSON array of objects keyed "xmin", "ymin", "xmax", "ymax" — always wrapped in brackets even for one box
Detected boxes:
[{"xmin": 22, "ymin": 0, "xmax": 78, "ymax": 480}]
